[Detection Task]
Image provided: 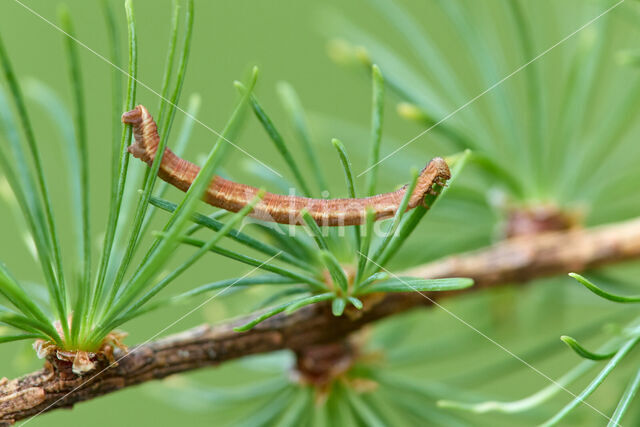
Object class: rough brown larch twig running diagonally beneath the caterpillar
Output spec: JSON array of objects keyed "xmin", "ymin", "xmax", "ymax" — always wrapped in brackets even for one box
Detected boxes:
[{"xmin": 0, "ymin": 218, "xmax": 640, "ymax": 424}]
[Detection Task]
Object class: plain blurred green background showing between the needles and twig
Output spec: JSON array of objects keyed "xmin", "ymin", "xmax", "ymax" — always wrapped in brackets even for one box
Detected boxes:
[{"xmin": 0, "ymin": 0, "xmax": 637, "ymax": 426}]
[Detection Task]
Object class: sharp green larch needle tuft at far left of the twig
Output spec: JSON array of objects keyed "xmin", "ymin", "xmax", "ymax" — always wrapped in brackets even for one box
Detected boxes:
[{"xmin": 0, "ymin": 1, "xmax": 255, "ymax": 350}]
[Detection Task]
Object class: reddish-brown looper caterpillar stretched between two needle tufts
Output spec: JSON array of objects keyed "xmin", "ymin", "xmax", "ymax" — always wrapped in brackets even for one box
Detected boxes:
[{"xmin": 122, "ymin": 105, "xmax": 451, "ymax": 226}]
